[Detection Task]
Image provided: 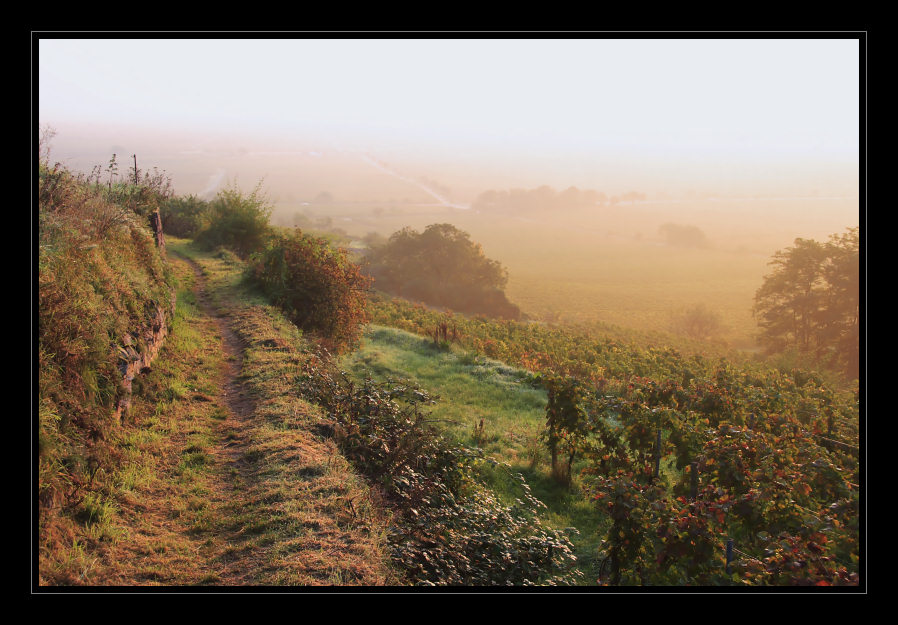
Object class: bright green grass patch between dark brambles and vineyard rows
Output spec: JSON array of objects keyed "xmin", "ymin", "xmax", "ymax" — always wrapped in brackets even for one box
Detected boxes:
[{"xmin": 342, "ymin": 325, "xmax": 608, "ymax": 583}]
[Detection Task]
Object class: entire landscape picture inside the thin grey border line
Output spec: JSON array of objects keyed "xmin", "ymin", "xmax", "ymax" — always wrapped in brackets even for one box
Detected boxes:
[{"xmin": 31, "ymin": 35, "xmax": 869, "ymax": 594}]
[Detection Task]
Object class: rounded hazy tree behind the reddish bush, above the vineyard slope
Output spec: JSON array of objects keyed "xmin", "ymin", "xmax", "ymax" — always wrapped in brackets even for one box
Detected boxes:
[{"xmin": 367, "ymin": 224, "xmax": 521, "ymax": 319}]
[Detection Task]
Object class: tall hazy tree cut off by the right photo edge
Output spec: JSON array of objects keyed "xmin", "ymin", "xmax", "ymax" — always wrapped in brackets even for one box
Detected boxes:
[{"xmin": 754, "ymin": 228, "xmax": 860, "ymax": 376}]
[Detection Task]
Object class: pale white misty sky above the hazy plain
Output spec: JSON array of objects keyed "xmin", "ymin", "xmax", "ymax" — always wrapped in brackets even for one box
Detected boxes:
[{"xmin": 38, "ymin": 39, "xmax": 859, "ymax": 160}]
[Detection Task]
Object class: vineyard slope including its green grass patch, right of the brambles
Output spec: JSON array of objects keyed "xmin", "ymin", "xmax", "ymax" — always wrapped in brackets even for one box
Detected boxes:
[{"xmin": 344, "ymin": 298, "xmax": 861, "ymax": 585}]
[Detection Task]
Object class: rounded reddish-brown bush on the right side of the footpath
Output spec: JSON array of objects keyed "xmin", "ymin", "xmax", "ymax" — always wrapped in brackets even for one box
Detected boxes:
[{"xmin": 250, "ymin": 232, "xmax": 371, "ymax": 352}]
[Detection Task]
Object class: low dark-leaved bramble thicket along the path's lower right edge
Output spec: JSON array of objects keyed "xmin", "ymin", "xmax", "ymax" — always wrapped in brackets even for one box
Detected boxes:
[{"xmin": 300, "ymin": 353, "xmax": 579, "ymax": 586}]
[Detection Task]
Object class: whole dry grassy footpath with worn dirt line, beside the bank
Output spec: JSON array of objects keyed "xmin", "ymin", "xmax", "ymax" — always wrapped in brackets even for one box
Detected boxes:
[{"xmin": 40, "ymin": 241, "xmax": 396, "ymax": 586}]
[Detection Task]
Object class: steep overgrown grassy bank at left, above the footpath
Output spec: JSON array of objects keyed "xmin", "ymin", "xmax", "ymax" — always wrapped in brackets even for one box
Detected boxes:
[{"xmin": 35, "ymin": 158, "xmax": 173, "ymax": 560}]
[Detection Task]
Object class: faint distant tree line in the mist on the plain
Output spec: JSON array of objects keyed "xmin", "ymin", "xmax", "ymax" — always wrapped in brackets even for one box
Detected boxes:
[{"xmin": 472, "ymin": 185, "xmax": 646, "ymax": 212}]
